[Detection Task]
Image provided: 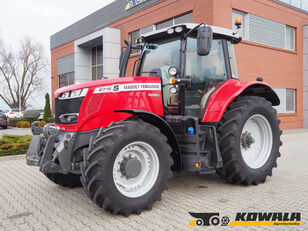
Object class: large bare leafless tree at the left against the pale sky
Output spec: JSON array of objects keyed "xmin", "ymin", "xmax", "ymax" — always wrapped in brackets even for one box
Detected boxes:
[{"xmin": 0, "ymin": 38, "xmax": 47, "ymax": 110}]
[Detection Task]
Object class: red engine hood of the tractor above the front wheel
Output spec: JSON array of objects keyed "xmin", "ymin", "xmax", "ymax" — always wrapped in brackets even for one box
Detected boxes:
[{"xmin": 55, "ymin": 77, "xmax": 163, "ymax": 131}]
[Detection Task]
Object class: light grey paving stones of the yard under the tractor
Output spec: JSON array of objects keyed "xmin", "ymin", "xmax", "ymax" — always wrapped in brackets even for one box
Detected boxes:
[{"xmin": 0, "ymin": 132, "xmax": 308, "ymax": 231}]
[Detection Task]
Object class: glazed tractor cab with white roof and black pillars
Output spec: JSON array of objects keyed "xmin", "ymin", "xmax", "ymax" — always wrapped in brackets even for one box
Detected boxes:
[{"xmin": 120, "ymin": 24, "xmax": 241, "ymax": 119}]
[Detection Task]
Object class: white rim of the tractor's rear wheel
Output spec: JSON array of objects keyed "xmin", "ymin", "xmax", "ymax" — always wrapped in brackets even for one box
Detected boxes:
[{"xmin": 240, "ymin": 114, "xmax": 273, "ymax": 169}]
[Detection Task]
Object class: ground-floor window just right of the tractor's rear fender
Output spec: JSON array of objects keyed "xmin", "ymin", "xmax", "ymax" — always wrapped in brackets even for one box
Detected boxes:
[{"xmin": 274, "ymin": 88, "xmax": 296, "ymax": 113}]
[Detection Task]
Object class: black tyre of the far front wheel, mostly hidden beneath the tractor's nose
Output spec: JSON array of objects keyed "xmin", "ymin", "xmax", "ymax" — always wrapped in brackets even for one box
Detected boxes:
[{"xmin": 44, "ymin": 173, "xmax": 82, "ymax": 188}]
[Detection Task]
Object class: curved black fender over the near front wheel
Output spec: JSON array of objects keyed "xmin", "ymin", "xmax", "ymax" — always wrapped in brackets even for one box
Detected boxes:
[{"xmin": 115, "ymin": 109, "xmax": 182, "ymax": 171}]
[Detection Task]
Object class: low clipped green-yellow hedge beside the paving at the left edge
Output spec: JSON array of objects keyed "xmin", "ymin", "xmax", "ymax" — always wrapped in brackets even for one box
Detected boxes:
[{"xmin": 0, "ymin": 135, "xmax": 32, "ymax": 156}]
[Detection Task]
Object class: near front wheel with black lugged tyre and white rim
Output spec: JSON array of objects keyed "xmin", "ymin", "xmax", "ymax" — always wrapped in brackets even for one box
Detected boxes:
[{"xmin": 81, "ymin": 120, "xmax": 173, "ymax": 216}]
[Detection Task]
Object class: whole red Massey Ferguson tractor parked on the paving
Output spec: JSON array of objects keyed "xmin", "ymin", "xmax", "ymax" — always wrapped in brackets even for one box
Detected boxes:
[{"xmin": 27, "ymin": 20, "xmax": 282, "ymax": 216}]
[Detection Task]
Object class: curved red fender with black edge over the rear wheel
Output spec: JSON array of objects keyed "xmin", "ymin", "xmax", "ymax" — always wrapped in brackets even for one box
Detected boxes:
[{"xmin": 201, "ymin": 79, "xmax": 280, "ymax": 123}]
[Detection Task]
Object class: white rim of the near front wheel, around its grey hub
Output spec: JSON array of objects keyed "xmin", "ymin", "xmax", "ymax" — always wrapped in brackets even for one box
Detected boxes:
[{"xmin": 113, "ymin": 141, "xmax": 159, "ymax": 198}]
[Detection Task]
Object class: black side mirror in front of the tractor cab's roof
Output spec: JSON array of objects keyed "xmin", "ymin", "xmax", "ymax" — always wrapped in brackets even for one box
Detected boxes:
[{"xmin": 197, "ymin": 26, "xmax": 213, "ymax": 56}]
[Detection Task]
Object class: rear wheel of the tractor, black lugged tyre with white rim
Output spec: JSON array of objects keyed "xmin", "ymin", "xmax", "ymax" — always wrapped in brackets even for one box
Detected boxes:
[{"xmin": 217, "ymin": 96, "xmax": 282, "ymax": 185}]
